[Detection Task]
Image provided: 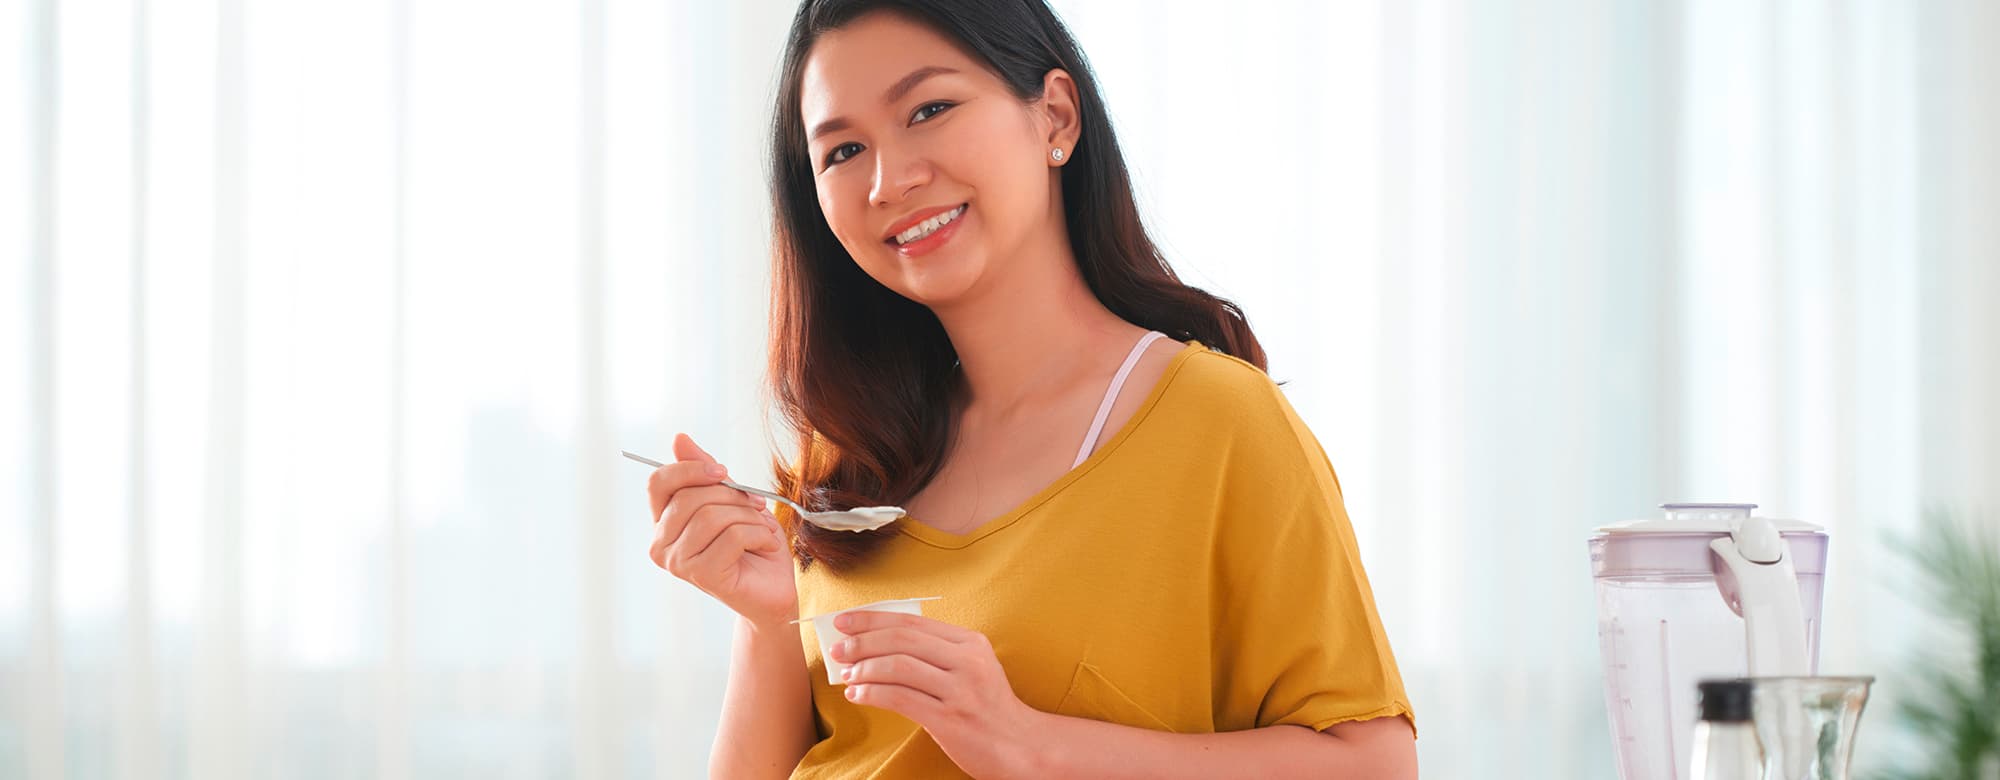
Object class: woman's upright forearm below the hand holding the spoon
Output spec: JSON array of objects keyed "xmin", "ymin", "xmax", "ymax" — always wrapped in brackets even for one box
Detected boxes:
[{"xmin": 708, "ymin": 618, "xmax": 816, "ymax": 778}]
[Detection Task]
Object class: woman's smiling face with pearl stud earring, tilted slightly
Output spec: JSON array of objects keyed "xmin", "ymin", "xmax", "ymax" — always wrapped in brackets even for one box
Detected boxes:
[{"xmin": 800, "ymin": 12, "xmax": 1074, "ymax": 308}]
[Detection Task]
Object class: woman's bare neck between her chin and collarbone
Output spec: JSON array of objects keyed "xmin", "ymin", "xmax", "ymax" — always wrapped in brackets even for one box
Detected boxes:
[{"xmin": 936, "ymin": 236, "xmax": 1138, "ymax": 416}]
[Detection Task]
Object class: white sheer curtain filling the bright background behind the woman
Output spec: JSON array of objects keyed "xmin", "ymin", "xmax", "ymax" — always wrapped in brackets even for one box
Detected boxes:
[{"xmin": 0, "ymin": 0, "xmax": 2000, "ymax": 778}]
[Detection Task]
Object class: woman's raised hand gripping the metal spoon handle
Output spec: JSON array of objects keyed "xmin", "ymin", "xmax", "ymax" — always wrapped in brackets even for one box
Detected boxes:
[{"xmin": 646, "ymin": 434, "xmax": 798, "ymax": 626}]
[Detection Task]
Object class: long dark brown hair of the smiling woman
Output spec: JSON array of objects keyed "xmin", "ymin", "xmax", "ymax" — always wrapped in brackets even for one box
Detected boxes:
[{"xmin": 770, "ymin": 0, "xmax": 1266, "ymax": 572}]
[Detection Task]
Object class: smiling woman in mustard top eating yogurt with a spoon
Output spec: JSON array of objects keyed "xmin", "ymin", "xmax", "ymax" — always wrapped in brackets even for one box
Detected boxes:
[{"xmin": 648, "ymin": 0, "xmax": 1416, "ymax": 778}]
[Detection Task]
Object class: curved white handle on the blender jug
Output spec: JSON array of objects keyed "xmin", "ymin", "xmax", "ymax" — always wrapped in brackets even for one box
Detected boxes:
[{"xmin": 1708, "ymin": 518, "xmax": 1812, "ymax": 678}]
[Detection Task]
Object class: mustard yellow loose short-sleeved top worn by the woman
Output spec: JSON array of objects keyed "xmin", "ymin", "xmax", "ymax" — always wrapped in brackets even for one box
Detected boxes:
[{"xmin": 792, "ymin": 342, "xmax": 1410, "ymax": 778}]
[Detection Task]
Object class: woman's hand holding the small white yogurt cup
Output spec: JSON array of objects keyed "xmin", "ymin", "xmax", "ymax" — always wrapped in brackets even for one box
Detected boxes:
[{"xmin": 834, "ymin": 610, "xmax": 1044, "ymax": 778}]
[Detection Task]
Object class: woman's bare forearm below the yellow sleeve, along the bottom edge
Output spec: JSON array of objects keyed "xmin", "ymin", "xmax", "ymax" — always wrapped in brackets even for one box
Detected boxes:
[{"xmin": 1032, "ymin": 714, "xmax": 1416, "ymax": 778}]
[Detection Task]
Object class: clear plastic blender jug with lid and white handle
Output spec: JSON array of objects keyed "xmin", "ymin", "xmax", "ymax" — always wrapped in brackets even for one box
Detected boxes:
[{"xmin": 1590, "ymin": 504, "xmax": 1826, "ymax": 780}]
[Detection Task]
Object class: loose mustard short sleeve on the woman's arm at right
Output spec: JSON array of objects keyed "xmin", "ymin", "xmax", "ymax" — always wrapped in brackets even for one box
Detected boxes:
[{"xmin": 1212, "ymin": 380, "xmax": 1416, "ymax": 730}]
